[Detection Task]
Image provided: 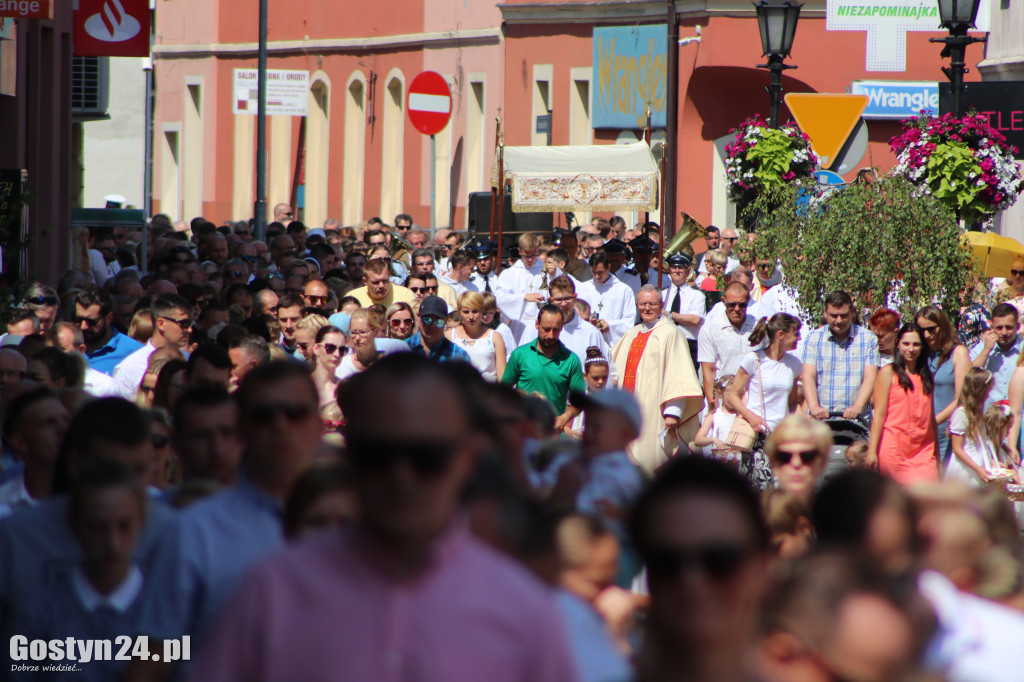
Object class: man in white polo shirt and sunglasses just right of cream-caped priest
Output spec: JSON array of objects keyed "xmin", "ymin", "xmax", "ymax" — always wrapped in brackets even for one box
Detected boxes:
[{"xmin": 697, "ymin": 282, "xmax": 757, "ymax": 411}]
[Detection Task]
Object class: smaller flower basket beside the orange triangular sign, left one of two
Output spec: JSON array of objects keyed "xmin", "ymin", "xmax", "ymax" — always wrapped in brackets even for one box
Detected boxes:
[{"xmin": 725, "ymin": 114, "xmax": 818, "ymax": 204}]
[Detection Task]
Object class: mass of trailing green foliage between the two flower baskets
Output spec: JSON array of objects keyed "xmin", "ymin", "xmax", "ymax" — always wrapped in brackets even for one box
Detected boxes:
[{"xmin": 744, "ymin": 176, "xmax": 975, "ymax": 325}]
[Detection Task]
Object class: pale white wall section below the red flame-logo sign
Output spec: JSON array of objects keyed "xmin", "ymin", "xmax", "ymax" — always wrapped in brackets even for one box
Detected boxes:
[{"xmin": 82, "ymin": 57, "xmax": 145, "ymax": 208}]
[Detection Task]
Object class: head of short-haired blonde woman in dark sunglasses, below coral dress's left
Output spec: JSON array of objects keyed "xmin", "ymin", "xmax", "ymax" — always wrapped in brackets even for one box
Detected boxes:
[{"xmin": 765, "ymin": 415, "xmax": 833, "ymax": 509}]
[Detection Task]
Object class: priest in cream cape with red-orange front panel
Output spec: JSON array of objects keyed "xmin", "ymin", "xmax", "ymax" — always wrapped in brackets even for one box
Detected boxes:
[{"xmin": 609, "ymin": 285, "xmax": 703, "ymax": 474}]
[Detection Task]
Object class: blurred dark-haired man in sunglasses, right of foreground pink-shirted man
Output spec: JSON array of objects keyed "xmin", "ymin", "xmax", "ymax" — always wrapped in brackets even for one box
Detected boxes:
[{"xmin": 630, "ymin": 457, "xmax": 770, "ymax": 680}]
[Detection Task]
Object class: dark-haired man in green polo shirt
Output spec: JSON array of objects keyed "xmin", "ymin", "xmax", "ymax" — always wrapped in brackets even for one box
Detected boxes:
[{"xmin": 502, "ymin": 303, "xmax": 587, "ymax": 431}]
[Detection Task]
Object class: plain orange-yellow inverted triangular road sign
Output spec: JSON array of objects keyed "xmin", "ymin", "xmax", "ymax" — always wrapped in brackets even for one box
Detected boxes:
[{"xmin": 785, "ymin": 92, "xmax": 867, "ymax": 168}]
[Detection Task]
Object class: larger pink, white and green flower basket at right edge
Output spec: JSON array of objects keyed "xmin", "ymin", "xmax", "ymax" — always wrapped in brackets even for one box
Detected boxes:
[{"xmin": 890, "ymin": 114, "xmax": 1024, "ymax": 223}]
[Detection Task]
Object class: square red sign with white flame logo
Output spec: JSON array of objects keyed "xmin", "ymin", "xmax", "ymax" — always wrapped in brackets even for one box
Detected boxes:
[{"xmin": 75, "ymin": 0, "xmax": 150, "ymax": 56}]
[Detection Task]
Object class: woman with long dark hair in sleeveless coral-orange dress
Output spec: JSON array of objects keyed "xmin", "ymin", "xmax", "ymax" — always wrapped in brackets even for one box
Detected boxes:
[{"xmin": 867, "ymin": 323, "xmax": 938, "ymax": 484}]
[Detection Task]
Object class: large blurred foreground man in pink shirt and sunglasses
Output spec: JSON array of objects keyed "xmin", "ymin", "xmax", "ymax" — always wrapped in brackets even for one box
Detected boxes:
[{"xmin": 193, "ymin": 353, "xmax": 577, "ymax": 682}]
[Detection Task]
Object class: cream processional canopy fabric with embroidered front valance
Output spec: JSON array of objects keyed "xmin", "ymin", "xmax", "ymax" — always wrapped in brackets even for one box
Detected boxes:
[{"xmin": 490, "ymin": 142, "xmax": 658, "ymax": 213}]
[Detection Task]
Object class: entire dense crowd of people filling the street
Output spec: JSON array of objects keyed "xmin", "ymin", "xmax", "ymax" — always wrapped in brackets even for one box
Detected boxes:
[{"xmin": 0, "ymin": 205, "xmax": 1024, "ymax": 682}]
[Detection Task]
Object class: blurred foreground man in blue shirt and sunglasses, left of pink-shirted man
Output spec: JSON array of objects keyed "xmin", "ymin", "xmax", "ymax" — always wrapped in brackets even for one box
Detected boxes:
[{"xmin": 134, "ymin": 363, "xmax": 323, "ymax": 679}]
